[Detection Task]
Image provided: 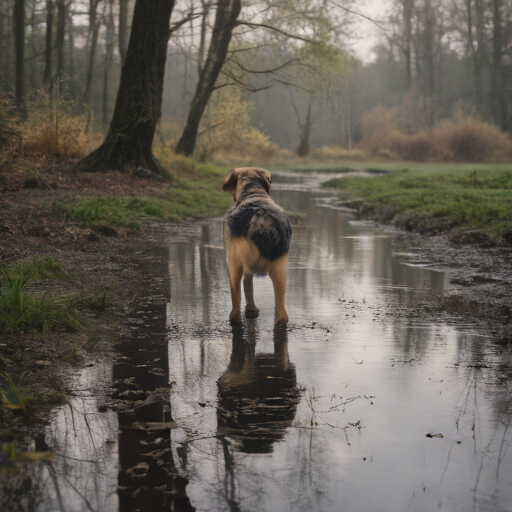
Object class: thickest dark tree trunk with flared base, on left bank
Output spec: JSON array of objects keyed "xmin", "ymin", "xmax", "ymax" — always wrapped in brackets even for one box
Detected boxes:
[{"xmin": 78, "ymin": 0, "xmax": 175, "ymax": 174}]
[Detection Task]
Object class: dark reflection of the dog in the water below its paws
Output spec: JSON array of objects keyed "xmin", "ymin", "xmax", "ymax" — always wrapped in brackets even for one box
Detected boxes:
[{"xmin": 217, "ymin": 320, "xmax": 300, "ymax": 453}]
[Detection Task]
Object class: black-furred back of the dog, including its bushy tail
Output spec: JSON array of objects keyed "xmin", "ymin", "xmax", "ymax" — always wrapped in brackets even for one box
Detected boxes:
[{"xmin": 224, "ymin": 197, "xmax": 292, "ymax": 261}]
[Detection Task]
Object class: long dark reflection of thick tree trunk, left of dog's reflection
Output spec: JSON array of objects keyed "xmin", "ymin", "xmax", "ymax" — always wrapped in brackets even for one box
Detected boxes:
[{"xmin": 113, "ymin": 247, "xmax": 194, "ymax": 512}]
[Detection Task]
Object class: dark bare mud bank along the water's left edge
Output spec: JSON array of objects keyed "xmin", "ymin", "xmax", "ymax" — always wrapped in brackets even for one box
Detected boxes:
[{"xmin": 0, "ymin": 224, "xmax": 180, "ymax": 444}]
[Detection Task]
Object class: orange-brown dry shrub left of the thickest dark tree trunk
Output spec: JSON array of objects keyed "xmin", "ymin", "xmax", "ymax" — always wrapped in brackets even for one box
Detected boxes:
[{"xmin": 21, "ymin": 86, "xmax": 101, "ymax": 158}]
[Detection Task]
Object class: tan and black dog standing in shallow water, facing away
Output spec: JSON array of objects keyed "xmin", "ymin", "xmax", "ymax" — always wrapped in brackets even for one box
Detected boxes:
[{"xmin": 222, "ymin": 167, "xmax": 292, "ymax": 326}]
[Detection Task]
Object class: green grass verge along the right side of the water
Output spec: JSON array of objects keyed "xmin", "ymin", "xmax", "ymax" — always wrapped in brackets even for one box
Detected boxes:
[{"xmin": 322, "ymin": 163, "xmax": 512, "ymax": 243}]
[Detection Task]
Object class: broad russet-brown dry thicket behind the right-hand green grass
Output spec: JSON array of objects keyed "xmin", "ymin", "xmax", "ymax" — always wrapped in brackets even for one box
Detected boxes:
[{"xmin": 359, "ymin": 98, "xmax": 512, "ymax": 162}]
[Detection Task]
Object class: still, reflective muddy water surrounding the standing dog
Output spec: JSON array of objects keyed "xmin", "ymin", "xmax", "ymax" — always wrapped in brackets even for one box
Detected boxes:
[{"xmin": 8, "ymin": 175, "xmax": 512, "ymax": 512}]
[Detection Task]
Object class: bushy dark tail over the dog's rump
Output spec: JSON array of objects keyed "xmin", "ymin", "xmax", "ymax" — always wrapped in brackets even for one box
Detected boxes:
[{"xmin": 247, "ymin": 205, "xmax": 292, "ymax": 261}]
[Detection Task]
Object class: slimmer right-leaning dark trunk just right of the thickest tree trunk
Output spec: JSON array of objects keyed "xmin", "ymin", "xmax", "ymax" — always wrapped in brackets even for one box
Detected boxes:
[{"xmin": 176, "ymin": 0, "xmax": 242, "ymax": 155}]
